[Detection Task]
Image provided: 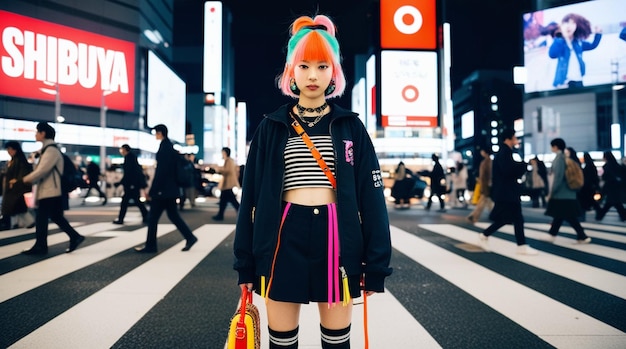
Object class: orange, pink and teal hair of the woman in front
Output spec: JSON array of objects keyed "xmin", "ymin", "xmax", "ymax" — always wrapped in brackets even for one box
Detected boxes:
[{"xmin": 278, "ymin": 15, "xmax": 346, "ymax": 98}]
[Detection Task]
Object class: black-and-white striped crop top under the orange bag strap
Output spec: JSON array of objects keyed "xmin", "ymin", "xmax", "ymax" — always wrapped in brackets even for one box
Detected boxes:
[{"xmin": 283, "ymin": 111, "xmax": 335, "ymax": 191}]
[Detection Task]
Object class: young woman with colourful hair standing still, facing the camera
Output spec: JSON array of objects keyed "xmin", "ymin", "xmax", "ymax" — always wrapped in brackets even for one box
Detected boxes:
[{"xmin": 234, "ymin": 15, "xmax": 391, "ymax": 348}]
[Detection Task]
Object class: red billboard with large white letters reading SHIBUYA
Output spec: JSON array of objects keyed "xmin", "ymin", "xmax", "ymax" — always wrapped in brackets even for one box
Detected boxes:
[{"xmin": 0, "ymin": 11, "xmax": 135, "ymax": 111}]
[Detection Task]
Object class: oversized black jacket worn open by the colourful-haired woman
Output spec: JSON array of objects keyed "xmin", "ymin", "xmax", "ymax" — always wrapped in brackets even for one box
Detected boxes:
[{"xmin": 234, "ymin": 104, "xmax": 391, "ymax": 292}]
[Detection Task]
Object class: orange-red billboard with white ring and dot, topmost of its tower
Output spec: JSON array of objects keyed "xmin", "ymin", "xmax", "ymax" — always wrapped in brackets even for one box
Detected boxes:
[{"xmin": 380, "ymin": 0, "xmax": 437, "ymax": 50}]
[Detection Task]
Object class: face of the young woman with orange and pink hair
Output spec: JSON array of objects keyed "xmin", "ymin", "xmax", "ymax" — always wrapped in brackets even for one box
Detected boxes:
[{"xmin": 294, "ymin": 61, "xmax": 333, "ymax": 99}]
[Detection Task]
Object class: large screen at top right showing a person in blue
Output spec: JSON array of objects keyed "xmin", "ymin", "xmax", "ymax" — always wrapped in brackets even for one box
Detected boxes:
[{"xmin": 523, "ymin": 0, "xmax": 626, "ymax": 93}]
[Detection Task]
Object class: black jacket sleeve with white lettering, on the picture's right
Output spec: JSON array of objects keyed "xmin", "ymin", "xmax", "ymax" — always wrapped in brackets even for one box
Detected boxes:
[{"xmin": 354, "ymin": 122, "xmax": 392, "ymax": 292}]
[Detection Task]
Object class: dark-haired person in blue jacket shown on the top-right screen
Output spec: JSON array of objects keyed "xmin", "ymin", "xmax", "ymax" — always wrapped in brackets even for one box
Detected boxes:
[{"xmin": 548, "ymin": 13, "xmax": 602, "ymax": 88}]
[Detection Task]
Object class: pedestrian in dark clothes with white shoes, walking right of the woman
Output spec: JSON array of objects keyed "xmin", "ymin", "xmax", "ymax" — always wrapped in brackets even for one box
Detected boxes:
[{"xmin": 478, "ymin": 129, "xmax": 537, "ymax": 255}]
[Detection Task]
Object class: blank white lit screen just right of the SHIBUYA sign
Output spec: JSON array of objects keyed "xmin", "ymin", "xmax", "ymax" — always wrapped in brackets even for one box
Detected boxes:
[{"xmin": 147, "ymin": 51, "xmax": 187, "ymax": 143}]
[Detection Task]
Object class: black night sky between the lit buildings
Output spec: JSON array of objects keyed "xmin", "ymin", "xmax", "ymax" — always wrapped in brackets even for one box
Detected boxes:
[{"xmin": 175, "ymin": 0, "xmax": 532, "ymax": 130}]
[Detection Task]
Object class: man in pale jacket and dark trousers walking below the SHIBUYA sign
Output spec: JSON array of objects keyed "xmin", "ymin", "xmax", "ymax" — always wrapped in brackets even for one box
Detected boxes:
[{"xmin": 10, "ymin": 122, "xmax": 85, "ymax": 255}]
